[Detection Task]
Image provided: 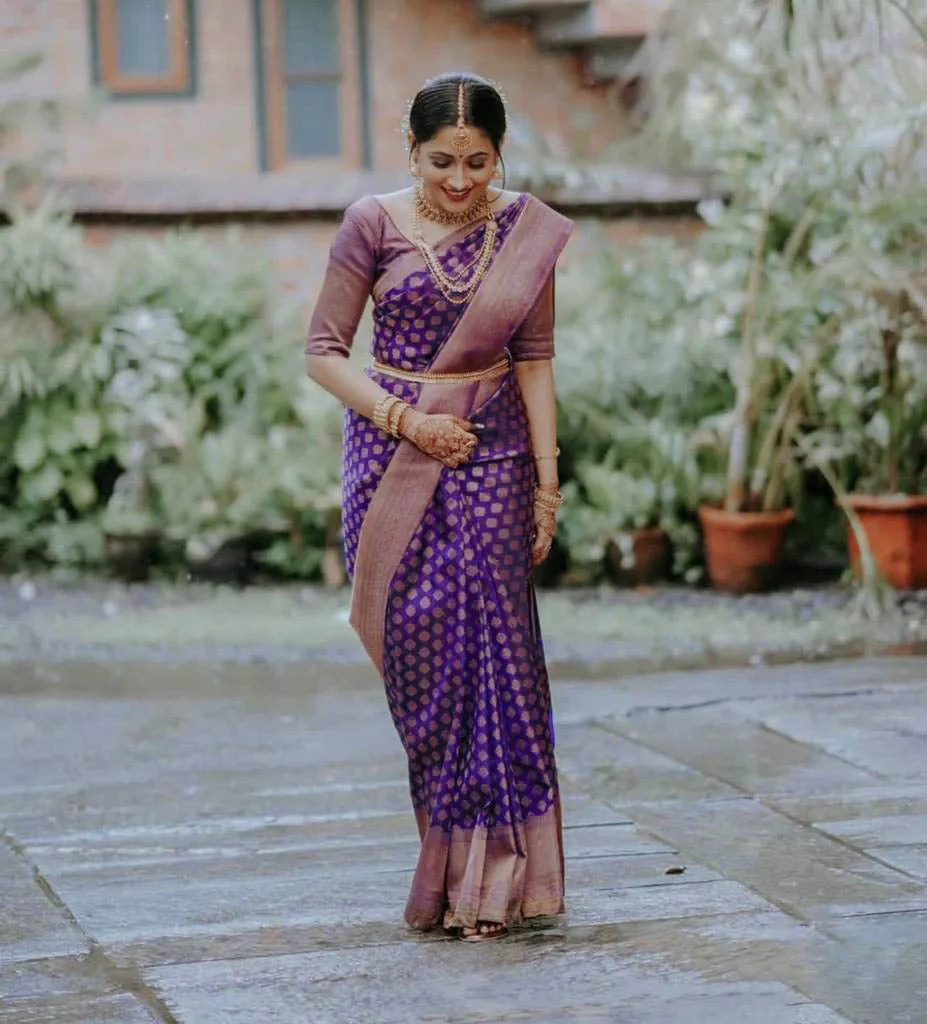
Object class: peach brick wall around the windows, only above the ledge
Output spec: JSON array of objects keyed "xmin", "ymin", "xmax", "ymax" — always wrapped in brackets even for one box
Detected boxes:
[{"xmin": 0, "ymin": 0, "xmax": 621, "ymax": 178}]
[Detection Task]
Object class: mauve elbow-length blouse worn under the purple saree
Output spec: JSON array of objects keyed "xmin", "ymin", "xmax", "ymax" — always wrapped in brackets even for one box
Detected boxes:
[{"xmin": 305, "ymin": 196, "xmax": 554, "ymax": 362}]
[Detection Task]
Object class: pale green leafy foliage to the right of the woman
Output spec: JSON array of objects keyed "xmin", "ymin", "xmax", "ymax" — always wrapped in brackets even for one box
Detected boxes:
[{"xmin": 559, "ymin": 0, "xmax": 927, "ymax": 577}]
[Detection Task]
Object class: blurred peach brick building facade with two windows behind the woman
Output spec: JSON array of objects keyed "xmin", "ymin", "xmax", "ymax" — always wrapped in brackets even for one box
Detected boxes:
[{"xmin": 0, "ymin": 0, "xmax": 697, "ymax": 303}]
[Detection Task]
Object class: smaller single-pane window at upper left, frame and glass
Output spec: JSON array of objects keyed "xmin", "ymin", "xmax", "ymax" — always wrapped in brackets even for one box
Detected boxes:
[{"xmin": 92, "ymin": 0, "xmax": 194, "ymax": 95}]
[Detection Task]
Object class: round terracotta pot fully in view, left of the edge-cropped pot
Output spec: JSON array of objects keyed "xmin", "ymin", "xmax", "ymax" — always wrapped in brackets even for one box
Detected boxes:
[{"xmin": 699, "ymin": 505, "xmax": 795, "ymax": 594}]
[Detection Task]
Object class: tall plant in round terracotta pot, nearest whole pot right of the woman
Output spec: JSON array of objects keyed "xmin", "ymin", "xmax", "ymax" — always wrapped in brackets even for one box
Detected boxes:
[{"xmin": 626, "ymin": 0, "xmax": 925, "ymax": 590}]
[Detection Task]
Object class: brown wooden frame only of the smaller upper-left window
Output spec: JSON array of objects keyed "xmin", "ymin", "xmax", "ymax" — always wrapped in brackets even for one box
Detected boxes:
[{"xmin": 91, "ymin": 0, "xmax": 196, "ymax": 97}]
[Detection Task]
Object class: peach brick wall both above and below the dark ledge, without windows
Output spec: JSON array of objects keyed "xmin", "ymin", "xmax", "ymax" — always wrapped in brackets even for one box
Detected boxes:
[{"xmin": 0, "ymin": 0, "xmax": 693, "ymax": 314}]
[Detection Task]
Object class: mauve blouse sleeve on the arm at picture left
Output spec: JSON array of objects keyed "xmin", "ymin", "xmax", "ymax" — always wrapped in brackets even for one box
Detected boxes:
[{"xmin": 305, "ymin": 200, "xmax": 377, "ymax": 357}]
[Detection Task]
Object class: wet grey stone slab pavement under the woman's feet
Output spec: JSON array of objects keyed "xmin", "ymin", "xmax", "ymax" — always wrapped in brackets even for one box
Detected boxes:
[{"xmin": 0, "ymin": 657, "xmax": 927, "ymax": 1024}]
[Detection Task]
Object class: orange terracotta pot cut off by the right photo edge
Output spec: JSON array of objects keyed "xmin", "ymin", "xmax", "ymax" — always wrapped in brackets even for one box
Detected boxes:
[{"xmin": 837, "ymin": 495, "xmax": 927, "ymax": 590}]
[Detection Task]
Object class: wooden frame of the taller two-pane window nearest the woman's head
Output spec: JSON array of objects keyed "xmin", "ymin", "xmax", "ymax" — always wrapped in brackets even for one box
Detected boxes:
[{"xmin": 255, "ymin": 0, "xmax": 365, "ymax": 171}]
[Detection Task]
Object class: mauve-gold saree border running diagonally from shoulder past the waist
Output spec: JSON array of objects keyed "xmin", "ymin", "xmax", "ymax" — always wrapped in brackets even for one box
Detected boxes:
[{"xmin": 349, "ymin": 196, "xmax": 573, "ymax": 674}]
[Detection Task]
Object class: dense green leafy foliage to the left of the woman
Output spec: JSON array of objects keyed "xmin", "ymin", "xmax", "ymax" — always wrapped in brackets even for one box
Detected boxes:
[{"xmin": 0, "ymin": 202, "xmax": 340, "ymax": 574}]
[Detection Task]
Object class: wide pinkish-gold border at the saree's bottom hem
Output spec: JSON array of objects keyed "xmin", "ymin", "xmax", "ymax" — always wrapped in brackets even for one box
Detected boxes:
[{"xmin": 405, "ymin": 801, "xmax": 564, "ymax": 931}]
